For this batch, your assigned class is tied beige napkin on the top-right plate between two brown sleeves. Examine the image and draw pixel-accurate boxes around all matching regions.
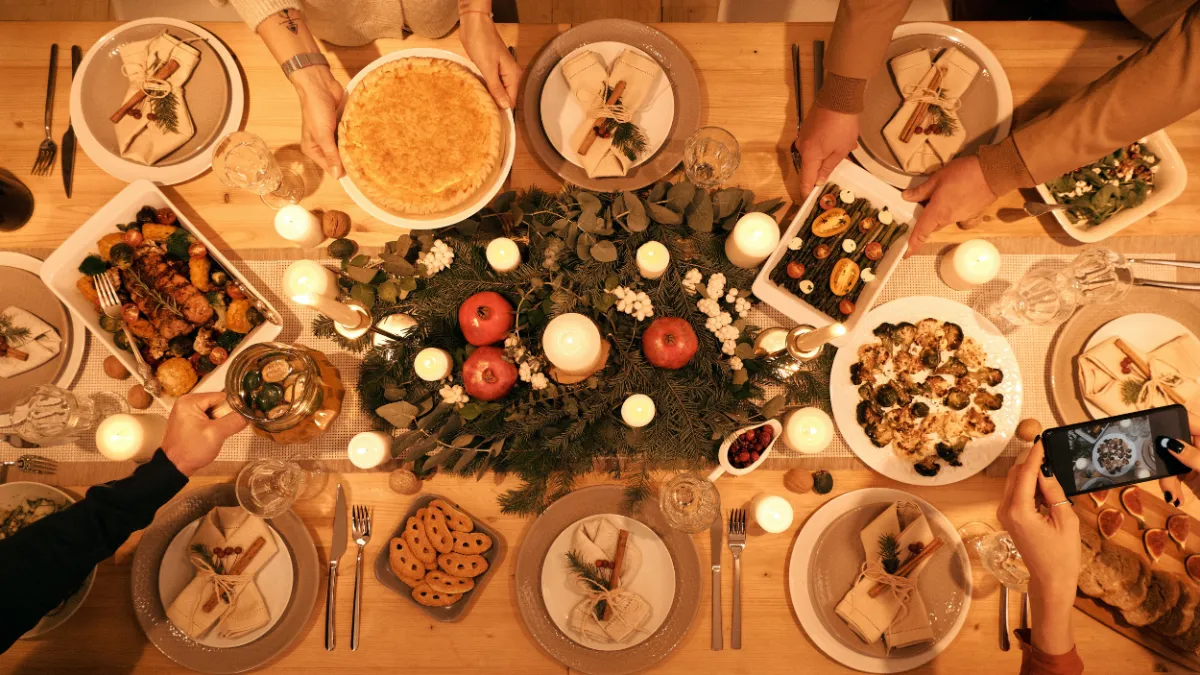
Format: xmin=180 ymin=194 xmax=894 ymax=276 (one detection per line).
xmin=883 ymin=47 xmax=979 ymax=174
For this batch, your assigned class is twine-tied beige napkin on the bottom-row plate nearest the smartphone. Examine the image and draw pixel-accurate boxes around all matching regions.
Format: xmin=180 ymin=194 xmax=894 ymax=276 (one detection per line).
xmin=834 ymin=502 xmax=934 ymax=651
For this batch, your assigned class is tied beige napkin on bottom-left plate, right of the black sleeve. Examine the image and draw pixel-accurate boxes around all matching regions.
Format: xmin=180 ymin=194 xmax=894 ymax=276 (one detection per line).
xmin=167 ymin=507 xmax=277 ymax=639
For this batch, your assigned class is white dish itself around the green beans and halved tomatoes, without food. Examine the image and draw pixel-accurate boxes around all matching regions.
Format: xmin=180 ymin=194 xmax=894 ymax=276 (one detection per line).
xmin=751 ymin=160 xmax=922 ymax=347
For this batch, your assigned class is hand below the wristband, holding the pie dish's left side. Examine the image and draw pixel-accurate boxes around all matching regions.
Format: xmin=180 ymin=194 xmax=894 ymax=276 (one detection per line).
xmin=292 ymin=66 xmax=346 ymax=178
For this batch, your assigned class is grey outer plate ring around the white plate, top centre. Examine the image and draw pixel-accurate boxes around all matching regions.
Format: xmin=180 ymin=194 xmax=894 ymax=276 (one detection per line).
xmin=521 ymin=19 xmax=701 ymax=190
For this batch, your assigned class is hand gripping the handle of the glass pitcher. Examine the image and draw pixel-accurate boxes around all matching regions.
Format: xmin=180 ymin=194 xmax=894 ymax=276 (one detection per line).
xmin=162 ymin=392 xmax=246 ymax=476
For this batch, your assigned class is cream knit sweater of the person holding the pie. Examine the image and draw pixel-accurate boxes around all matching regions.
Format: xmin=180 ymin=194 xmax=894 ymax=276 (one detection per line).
xmin=212 ymin=0 xmax=458 ymax=47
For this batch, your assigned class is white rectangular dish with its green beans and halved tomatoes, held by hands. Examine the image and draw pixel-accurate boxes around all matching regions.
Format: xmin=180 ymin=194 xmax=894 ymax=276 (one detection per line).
xmin=754 ymin=161 xmax=920 ymax=346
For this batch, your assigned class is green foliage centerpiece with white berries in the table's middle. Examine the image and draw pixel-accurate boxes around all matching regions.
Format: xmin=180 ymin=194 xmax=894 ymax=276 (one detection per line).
xmin=313 ymin=176 xmax=828 ymax=514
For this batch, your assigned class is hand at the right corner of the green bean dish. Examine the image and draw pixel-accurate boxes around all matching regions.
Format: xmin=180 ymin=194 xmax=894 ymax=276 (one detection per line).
xmin=904 ymin=155 xmax=996 ymax=258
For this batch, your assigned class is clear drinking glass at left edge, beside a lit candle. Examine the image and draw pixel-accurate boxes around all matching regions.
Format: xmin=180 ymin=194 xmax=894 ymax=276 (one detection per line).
xmin=0 ymin=384 xmax=130 ymax=446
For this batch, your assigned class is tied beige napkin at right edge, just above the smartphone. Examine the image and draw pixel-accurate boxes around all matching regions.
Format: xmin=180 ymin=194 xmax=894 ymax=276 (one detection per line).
xmin=1079 ymin=335 xmax=1200 ymax=416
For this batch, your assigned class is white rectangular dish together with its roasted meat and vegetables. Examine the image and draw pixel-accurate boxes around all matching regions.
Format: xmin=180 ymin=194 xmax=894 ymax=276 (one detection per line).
xmin=42 ymin=180 xmax=282 ymax=408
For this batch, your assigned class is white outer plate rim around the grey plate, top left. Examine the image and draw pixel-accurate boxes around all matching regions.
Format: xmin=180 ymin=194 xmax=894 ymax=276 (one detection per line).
xmin=71 ymin=17 xmax=246 ymax=185
